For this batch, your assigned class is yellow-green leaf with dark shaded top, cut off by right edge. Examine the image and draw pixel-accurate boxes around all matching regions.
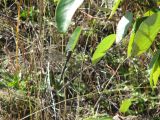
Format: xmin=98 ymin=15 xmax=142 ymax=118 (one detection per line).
xmin=149 ymin=50 xmax=160 ymax=88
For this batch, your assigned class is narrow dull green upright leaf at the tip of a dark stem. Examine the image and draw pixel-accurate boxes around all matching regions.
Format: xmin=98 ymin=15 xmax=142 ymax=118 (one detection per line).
xmin=66 ymin=26 xmax=82 ymax=52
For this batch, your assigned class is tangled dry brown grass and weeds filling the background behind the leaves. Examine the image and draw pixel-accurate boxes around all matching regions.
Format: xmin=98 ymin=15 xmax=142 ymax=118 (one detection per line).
xmin=0 ymin=0 xmax=160 ymax=120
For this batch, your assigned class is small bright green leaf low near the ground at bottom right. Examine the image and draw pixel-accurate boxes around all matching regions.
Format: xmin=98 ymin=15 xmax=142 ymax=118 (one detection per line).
xmin=119 ymin=99 xmax=133 ymax=113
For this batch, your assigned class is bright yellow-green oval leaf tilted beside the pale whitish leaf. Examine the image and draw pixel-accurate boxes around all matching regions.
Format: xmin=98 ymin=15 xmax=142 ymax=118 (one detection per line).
xmin=92 ymin=34 xmax=116 ymax=64
